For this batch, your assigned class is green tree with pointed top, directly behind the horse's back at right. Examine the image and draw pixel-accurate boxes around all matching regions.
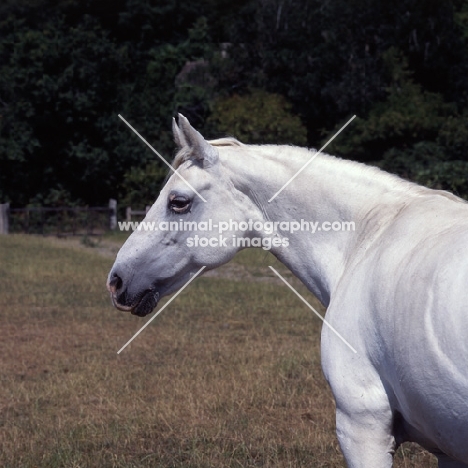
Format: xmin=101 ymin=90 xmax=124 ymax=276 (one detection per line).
xmin=334 ymin=48 xmax=468 ymax=198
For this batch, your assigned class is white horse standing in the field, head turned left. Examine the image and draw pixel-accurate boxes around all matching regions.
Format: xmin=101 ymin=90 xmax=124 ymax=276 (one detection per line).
xmin=108 ymin=116 xmax=468 ymax=468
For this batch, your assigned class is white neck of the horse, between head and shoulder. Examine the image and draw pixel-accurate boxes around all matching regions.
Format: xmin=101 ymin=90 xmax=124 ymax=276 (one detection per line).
xmin=220 ymin=146 xmax=416 ymax=306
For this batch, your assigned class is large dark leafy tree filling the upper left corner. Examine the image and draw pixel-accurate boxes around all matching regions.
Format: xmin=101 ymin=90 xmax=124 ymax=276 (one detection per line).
xmin=0 ymin=0 xmax=218 ymax=205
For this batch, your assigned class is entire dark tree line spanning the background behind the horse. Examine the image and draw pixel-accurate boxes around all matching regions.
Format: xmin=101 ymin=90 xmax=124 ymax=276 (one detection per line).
xmin=0 ymin=0 xmax=468 ymax=206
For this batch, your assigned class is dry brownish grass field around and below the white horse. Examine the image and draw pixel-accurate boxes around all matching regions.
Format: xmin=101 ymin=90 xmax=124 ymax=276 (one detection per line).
xmin=0 ymin=235 xmax=436 ymax=468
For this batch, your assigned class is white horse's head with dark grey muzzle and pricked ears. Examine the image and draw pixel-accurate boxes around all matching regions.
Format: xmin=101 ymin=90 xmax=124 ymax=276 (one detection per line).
xmin=107 ymin=115 xmax=261 ymax=317
